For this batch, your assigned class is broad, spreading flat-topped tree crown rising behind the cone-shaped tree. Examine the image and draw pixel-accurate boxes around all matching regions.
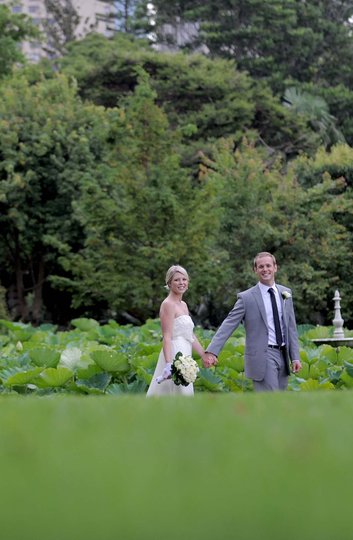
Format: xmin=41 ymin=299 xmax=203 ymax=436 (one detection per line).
xmin=61 ymin=34 xmax=320 ymax=161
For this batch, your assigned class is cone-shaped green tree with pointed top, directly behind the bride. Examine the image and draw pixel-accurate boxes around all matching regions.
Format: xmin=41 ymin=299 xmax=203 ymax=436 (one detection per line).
xmin=55 ymin=73 xmax=217 ymax=321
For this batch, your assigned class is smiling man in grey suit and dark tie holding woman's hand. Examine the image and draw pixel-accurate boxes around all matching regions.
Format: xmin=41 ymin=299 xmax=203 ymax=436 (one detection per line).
xmin=206 ymin=251 xmax=301 ymax=391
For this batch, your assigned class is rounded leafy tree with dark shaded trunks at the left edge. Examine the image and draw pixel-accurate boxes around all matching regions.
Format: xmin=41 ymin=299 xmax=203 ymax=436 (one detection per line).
xmin=0 ymin=75 xmax=106 ymax=322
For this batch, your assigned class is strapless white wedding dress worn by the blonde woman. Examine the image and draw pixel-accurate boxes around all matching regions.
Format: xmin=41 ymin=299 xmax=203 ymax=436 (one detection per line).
xmin=147 ymin=315 xmax=194 ymax=397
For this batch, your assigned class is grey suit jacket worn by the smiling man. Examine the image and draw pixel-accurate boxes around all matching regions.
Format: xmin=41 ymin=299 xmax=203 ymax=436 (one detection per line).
xmin=207 ymin=283 xmax=299 ymax=381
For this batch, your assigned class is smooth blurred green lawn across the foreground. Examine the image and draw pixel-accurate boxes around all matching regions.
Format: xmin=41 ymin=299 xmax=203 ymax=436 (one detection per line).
xmin=0 ymin=391 xmax=353 ymax=540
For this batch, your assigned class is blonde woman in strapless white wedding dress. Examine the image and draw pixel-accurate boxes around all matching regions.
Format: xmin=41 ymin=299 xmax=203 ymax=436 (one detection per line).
xmin=147 ymin=265 xmax=209 ymax=396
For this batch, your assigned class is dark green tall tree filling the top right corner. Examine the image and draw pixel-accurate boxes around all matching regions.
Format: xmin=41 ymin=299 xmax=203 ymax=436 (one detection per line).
xmin=154 ymin=0 xmax=353 ymax=91
